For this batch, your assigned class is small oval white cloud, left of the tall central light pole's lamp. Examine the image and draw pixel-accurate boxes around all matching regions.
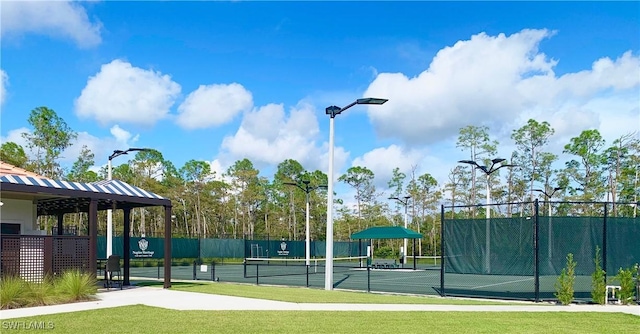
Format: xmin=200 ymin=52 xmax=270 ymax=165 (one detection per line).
xmin=176 ymin=83 xmax=253 ymax=129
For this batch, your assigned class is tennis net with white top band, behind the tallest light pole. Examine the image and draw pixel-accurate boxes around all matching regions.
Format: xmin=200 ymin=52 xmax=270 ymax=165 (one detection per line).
xmin=244 ymin=256 xmax=367 ymax=278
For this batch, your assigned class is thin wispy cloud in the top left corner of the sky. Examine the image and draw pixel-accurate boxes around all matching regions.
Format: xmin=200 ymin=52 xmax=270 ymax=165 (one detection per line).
xmin=0 ymin=1 xmax=102 ymax=48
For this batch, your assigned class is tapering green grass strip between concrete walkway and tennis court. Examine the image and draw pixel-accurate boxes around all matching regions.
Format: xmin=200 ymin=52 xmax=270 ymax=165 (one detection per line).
xmin=137 ymin=282 xmax=516 ymax=305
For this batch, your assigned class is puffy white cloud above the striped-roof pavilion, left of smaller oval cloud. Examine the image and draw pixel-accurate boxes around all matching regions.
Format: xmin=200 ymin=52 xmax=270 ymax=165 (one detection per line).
xmin=75 ymin=60 xmax=180 ymax=125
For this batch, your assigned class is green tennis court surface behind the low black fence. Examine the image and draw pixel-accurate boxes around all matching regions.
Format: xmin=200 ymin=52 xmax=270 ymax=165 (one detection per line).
xmin=126 ymin=258 xmax=591 ymax=300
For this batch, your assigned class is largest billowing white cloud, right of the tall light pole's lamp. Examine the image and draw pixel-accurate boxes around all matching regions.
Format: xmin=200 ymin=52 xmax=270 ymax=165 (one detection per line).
xmin=364 ymin=30 xmax=640 ymax=145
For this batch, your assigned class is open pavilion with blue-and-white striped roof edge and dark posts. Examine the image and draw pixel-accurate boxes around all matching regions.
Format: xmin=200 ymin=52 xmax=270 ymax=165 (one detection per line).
xmin=0 ymin=175 xmax=171 ymax=288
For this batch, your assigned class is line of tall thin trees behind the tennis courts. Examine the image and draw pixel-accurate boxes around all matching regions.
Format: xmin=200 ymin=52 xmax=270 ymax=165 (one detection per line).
xmin=0 ymin=107 xmax=640 ymax=254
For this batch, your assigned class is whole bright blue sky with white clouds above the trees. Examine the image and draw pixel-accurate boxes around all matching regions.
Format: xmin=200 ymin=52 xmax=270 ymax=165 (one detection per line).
xmin=0 ymin=1 xmax=640 ymax=196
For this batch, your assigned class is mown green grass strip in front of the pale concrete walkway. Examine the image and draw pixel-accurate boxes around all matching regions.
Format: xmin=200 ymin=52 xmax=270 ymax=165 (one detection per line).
xmin=6 ymin=305 xmax=640 ymax=334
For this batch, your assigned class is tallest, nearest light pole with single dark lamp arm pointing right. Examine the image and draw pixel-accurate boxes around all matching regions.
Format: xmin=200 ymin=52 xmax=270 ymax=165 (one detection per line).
xmin=324 ymin=98 xmax=388 ymax=290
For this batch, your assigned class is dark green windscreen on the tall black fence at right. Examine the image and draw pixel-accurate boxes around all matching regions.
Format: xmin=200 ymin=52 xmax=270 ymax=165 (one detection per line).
xmin=443 ymin=216 xmax=640 ymax=276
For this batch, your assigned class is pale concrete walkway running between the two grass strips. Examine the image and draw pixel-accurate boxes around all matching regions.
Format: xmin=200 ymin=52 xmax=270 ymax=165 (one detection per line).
xmin=0 ymin=287 xmax=640 ymax=320
